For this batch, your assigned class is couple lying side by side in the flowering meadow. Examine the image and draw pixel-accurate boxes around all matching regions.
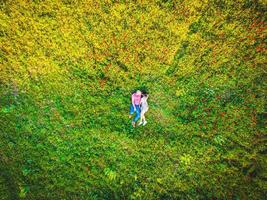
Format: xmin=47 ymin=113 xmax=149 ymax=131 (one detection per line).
xmin=129 ymin=90 xmax=148 ymax=127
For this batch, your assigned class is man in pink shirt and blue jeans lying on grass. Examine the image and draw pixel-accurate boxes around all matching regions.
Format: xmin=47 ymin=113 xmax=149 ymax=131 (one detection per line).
xmin=129 ymin=90 xmax=142 ymax=127
